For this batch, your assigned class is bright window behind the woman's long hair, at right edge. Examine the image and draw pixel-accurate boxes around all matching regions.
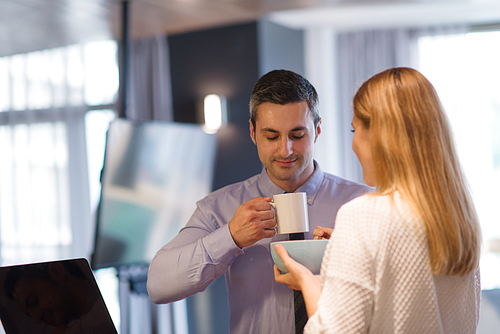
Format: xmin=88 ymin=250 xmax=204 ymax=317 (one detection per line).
xmin=419 ymin=32 xmax=500 ymax=289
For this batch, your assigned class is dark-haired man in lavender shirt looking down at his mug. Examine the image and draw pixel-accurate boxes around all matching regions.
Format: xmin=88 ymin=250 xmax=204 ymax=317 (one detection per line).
xmin=148 ymin=70 xmax=369 ymax=334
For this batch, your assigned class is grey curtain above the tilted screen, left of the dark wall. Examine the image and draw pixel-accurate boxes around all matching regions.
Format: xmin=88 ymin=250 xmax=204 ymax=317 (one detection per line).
xmin=127 ymin=36 xmax=173 ymax=122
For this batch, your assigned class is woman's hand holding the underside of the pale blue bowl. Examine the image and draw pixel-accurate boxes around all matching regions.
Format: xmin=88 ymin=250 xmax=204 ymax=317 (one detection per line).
xmin=274 ymin=244 xmax=315 ymax=290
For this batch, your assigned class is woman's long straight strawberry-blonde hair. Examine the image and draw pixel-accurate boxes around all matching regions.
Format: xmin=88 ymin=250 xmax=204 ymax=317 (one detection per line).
xmin=353 ymin=68 xmax=481 ymax=275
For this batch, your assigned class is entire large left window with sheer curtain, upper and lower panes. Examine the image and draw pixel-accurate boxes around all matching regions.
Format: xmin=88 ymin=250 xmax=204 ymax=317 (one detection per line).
xmin=0 ymin=41 xmax=118 ymax=265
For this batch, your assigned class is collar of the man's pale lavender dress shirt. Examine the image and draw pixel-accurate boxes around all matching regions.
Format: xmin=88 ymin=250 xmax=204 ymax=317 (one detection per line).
xmin=259 ymin=160 xmax=324 ymax=205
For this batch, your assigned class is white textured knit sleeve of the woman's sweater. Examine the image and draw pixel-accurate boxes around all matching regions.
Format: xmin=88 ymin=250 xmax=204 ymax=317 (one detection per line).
xmin=305 ymin=196 xmax=376 ymax=333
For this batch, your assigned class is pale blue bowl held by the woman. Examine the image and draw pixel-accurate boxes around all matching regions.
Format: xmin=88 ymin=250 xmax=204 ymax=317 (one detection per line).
xmin=271 ymin=240 xmax=328 ymax=275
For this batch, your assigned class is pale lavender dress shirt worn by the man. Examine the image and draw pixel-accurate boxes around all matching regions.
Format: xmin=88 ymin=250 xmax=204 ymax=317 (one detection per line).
xmin=148 ymin=162 xmax=370 ymax=334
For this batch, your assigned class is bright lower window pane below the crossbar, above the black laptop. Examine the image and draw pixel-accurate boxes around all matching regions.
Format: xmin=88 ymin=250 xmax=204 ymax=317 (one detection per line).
xmin=0 ymin=122 xmax=72 ymax=263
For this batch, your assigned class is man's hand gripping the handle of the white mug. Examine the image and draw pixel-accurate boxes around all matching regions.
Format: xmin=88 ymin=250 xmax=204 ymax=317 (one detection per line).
xmin=229 ymin=197 xmax=276 ymax=248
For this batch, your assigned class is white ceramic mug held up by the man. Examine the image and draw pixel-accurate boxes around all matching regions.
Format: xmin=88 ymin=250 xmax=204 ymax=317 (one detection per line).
xmin=271 ymin=192 xmax=309 ymax=234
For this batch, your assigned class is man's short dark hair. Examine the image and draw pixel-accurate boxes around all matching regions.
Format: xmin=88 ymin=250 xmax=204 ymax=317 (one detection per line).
xmin=250 ymin=70 xmax=320 ymax=128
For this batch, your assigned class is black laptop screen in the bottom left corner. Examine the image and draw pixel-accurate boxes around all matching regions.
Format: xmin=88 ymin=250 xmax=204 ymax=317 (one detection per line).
xmin=0 ymin=258 xmax=117 ymax=334
